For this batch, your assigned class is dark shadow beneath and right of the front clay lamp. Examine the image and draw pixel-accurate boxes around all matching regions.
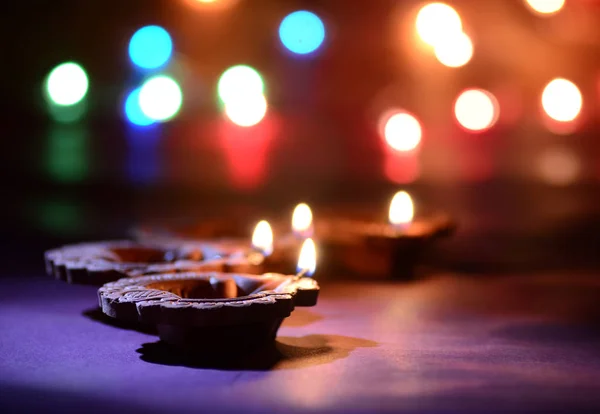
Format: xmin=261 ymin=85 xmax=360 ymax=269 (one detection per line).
xmin=137 ymin=335 xmax=378 ymax=371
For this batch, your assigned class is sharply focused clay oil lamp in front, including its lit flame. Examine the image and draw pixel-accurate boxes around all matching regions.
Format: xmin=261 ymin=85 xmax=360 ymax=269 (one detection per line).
xmin=98 ymin=239 xmax=319 ymax=352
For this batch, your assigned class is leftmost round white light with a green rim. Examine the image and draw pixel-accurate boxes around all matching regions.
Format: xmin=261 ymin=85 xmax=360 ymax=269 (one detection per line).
xmin=46 ymin=62 xmax=89 ymax=106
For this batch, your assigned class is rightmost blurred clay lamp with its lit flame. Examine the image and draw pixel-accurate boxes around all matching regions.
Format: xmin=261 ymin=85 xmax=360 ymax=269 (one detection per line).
xmin=315 ymin=191 xmax=455 ymax=279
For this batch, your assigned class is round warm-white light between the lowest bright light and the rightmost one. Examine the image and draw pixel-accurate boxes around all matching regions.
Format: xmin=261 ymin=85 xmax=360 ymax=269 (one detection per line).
xmin=454 ymin=89 xmax=500 ymax=132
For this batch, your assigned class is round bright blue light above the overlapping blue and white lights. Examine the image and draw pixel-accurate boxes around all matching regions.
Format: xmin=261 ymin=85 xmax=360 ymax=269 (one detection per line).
xmin=129 ymin=26 xmax=173 ymax=69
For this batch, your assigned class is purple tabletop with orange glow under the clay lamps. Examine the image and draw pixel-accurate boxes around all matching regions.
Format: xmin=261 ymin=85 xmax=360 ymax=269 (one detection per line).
xmin=0 ymin=275 xmax=600 ymax=413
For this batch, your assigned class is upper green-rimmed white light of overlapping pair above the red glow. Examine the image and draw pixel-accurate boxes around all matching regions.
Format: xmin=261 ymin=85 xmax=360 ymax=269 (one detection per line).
xmin=217 ymin=65 xmax=265 ymax=103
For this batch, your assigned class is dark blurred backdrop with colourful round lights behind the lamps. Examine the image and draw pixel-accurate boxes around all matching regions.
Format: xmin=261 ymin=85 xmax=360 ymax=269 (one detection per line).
xmin=0 ymin=0 xmax=600 ymax=273
